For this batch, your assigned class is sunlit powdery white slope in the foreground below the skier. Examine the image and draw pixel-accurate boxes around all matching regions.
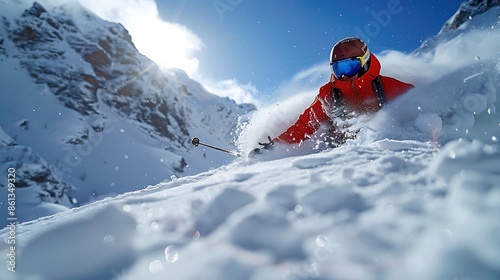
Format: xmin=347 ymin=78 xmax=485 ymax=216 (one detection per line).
xmin=0 ymin=0 xmax=500 ymax=280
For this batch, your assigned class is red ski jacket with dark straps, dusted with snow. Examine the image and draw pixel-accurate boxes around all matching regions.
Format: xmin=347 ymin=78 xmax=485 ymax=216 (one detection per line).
xmin=274 ymin=53 xmax=414 ymax=144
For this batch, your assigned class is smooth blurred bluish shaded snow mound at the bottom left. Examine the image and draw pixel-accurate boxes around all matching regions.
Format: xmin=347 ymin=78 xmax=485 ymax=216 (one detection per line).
xmin=18 ymin=205 xmax=137 ymax=279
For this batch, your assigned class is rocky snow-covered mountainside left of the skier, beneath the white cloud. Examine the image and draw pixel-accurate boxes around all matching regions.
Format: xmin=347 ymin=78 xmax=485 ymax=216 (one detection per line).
xmin=0 ymin=1 xmax=255 ymax=219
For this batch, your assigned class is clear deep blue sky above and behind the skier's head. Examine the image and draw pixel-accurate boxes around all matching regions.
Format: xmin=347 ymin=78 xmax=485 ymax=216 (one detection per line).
xmin=156 ymin=0 xmax=463 ymax=96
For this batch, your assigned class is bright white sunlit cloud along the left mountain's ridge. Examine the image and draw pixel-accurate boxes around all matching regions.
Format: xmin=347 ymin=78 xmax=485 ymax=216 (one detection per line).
xmin=78 ymin=0 xmax=259 ymax=105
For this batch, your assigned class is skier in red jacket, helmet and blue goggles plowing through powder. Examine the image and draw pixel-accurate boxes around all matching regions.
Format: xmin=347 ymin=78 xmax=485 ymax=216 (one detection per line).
xmin=251 ymin=37 xmax=414 ymax=154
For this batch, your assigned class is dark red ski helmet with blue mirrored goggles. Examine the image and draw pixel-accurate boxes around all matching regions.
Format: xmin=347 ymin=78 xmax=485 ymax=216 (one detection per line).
xmin=330 ymin=37 xmax=370 ymax=79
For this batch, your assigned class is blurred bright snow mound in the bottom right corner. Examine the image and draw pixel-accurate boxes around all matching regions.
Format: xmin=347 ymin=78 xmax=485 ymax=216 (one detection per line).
xmin=395 ymin=141 xmax=500 ymax=279
